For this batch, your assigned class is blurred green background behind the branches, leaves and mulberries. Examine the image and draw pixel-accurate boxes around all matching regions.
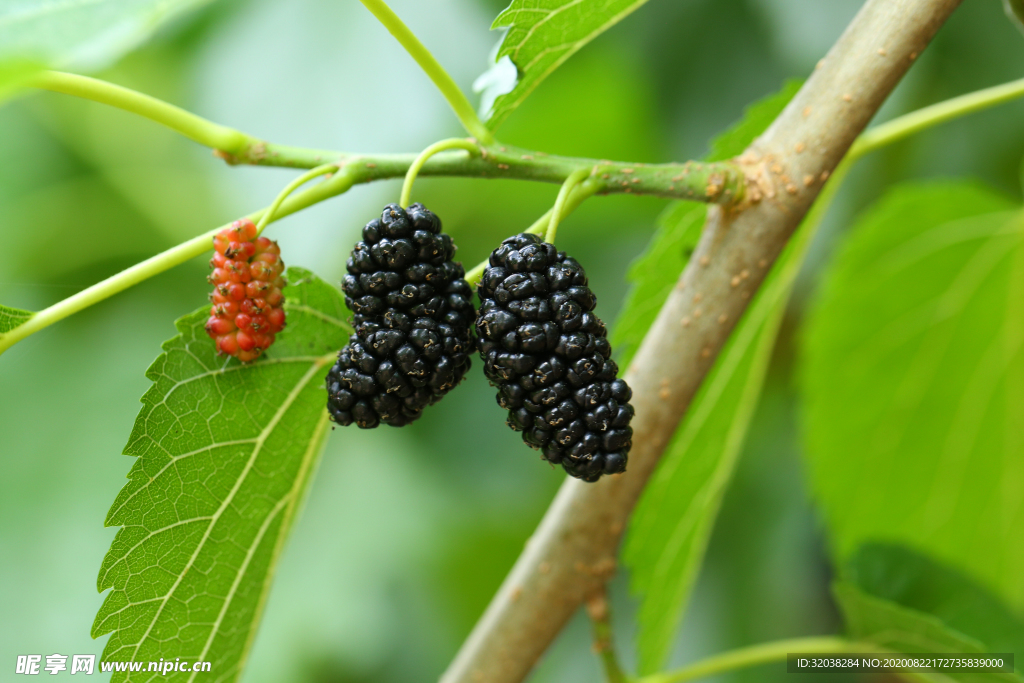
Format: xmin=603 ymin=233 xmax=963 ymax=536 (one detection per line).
xmin=6 ymin=0 xmax=1024 ymax=683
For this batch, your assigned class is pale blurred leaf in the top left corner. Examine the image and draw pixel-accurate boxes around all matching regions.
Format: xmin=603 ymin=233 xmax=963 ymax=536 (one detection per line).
xmin=0 ymin=0 xmax=216 ymax=98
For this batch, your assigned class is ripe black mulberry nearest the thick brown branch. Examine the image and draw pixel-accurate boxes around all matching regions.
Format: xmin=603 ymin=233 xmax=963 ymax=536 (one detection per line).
xmin=476 ymin=232 xmax=633 ymax=481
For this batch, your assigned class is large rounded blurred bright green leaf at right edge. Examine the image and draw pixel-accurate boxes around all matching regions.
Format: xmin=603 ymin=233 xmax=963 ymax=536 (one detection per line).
xmin=802 ymin=182 xmax=1024 ymax=609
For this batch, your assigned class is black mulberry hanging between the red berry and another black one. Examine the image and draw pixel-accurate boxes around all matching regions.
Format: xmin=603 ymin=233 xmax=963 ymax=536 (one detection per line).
xmin=327 ymin=204 xmax=475 ymax=429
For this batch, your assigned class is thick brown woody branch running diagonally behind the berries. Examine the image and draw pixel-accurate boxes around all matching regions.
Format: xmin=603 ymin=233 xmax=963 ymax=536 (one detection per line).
xmin=441 ymin=0 xmax=961 ymax=683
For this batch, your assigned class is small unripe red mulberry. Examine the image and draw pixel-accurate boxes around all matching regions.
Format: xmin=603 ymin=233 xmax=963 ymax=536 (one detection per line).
xmin=206 ymin=219 xmax=285 ymax=362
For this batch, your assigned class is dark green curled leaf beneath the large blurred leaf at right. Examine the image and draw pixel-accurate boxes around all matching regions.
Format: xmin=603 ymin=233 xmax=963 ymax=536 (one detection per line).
xmin=844 ymin=543 xmax=1024 ymax=652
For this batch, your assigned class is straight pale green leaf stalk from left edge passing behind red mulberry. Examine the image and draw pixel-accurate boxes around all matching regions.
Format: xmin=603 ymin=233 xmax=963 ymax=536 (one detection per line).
xmin=0 ymin=167 xmax=352 ymax=353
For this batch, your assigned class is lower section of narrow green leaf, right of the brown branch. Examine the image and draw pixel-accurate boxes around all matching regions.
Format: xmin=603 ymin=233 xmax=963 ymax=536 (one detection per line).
xmin=624 ymin=218 xmax=811 ymax=675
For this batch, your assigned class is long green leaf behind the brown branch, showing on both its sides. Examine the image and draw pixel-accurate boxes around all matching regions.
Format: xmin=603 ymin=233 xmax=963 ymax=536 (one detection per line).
xmin=614 ymin=83 xmax=802 ymax=674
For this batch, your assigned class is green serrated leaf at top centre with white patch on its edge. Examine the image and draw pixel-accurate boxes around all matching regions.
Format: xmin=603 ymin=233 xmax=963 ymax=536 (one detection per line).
xmin=476 ymin=0 xmax=647 ymax=130
